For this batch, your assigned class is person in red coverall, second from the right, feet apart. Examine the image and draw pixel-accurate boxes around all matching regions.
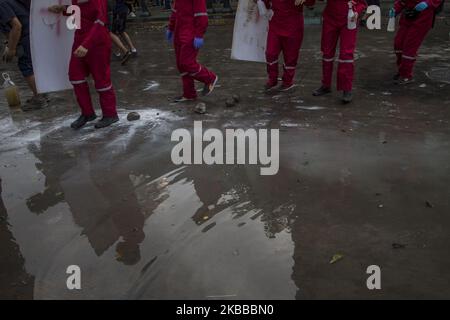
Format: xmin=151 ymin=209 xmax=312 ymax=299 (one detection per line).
xmin=313 ymin=0 xmax=367 ymax=103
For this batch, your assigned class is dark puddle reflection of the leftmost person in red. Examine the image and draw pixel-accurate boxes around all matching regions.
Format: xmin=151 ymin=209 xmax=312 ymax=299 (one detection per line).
xmin=27 ymin=131 xmax=146 ymax=265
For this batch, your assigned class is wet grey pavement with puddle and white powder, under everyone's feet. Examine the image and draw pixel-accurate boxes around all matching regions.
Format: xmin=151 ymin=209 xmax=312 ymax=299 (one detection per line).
xmin=0 ymin=20 xmax=450 ymax=299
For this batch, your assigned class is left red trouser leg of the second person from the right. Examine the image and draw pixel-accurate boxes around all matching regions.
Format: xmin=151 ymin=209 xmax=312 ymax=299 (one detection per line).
xmin=321 ymin=15 xmax=339 ymax=88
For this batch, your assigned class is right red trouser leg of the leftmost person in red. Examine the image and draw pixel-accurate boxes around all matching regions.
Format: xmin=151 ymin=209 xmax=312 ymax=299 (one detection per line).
xmin=86 ymin=41 xmax=117 ymax=117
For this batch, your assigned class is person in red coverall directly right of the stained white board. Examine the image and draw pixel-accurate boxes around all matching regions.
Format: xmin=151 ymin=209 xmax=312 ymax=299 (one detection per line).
xmin=260 ymin=0 xmax=315 ymax=92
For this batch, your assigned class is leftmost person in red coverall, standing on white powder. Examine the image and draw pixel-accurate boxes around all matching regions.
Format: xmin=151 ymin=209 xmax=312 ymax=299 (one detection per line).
xmin=48 ymin=0 xmax=119 ymax=129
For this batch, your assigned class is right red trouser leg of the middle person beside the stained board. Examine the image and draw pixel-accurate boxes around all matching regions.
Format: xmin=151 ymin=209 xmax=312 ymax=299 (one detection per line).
xmin=281 ymin=28 xmax=303 ymax=87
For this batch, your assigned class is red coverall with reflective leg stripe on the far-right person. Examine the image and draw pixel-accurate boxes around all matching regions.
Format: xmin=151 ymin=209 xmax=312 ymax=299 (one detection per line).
xmin=394 ymin=0 xmax=442 ymax=78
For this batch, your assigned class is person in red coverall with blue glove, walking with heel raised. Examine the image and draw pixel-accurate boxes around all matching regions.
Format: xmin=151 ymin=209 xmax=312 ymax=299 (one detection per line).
xmin=166 ymin=0 xmax=219 ymax=102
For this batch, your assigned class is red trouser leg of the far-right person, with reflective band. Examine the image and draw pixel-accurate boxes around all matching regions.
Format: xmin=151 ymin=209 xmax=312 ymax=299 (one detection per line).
xmin=399 ymin=9 xmax=434 ymax=78
